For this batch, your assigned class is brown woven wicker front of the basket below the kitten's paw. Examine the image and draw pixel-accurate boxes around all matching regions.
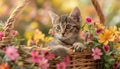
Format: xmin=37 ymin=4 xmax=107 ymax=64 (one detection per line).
xmin=50 ymin=49 xmax=100 ymax=69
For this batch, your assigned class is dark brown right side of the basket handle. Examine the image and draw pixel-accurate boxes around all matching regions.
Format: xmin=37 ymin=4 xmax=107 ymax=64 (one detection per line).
xmin=91 ymin=0 xmax=106 ymax=25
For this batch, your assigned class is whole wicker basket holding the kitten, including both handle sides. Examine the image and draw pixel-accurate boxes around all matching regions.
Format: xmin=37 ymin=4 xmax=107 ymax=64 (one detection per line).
xmin=0 ymin=0 xmax=105 ymax=69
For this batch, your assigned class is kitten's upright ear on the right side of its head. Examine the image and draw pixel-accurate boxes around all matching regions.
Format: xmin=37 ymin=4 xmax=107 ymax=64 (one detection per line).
xmin=69 ymin=7 xmax=81 ymax=22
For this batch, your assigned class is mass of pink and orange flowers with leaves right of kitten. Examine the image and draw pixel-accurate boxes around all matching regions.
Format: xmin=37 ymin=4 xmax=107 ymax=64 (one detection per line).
xmin=80 ymin=17 xmax=120 ymax=69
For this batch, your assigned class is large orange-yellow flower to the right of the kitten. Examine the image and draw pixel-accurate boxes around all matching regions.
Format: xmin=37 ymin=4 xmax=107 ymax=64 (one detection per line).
xmin=98 ymin=29 xmax=115 ymax=45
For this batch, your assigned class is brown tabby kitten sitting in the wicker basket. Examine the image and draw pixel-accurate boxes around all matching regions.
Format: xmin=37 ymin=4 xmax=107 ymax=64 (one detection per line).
xmin=47 ymin=7 xmax=85 ymax=57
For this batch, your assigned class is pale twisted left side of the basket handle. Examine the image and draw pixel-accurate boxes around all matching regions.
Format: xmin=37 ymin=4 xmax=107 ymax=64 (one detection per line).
xmin=4 ymin=0 xmax=29 ymax=37
